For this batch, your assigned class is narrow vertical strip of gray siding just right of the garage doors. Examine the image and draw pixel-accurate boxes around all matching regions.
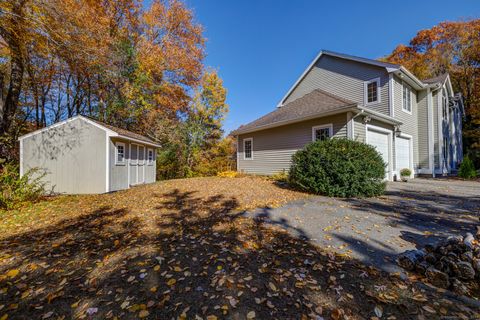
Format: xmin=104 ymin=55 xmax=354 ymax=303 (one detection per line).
xmin=417 ymin=90 xmax=430 ymax=169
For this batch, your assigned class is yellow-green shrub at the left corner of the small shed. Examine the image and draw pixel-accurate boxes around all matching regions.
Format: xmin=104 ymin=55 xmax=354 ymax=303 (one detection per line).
xmin=0 ymin=164 xmax=45 ymax=210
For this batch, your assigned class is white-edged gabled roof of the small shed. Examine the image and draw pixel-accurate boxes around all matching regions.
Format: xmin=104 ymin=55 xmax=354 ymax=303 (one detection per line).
xmin=18 ymin=115 xmax=160 ymax=147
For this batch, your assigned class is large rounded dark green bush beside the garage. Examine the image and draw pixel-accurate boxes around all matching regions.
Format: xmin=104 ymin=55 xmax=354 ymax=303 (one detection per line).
xmin=290 ymin=139 xmax=386 ymax=197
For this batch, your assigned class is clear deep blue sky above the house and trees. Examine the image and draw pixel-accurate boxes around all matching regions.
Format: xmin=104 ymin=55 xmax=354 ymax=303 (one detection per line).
xmin=182 ymin=0 xmax=480 ymax=133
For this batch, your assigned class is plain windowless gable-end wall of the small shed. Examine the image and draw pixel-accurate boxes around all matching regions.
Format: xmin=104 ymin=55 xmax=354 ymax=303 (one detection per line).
xmin=22 ymin=119 xmax=107 ymax=194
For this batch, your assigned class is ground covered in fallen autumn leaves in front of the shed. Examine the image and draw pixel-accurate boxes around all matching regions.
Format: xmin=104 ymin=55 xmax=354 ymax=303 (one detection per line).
xmin=0 ymin=177 xmax=478 ymax=320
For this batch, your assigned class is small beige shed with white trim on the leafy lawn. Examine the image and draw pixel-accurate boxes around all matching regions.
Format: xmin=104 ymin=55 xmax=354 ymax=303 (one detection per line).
xmin=19 ymin=115 xmax=159 ymax=194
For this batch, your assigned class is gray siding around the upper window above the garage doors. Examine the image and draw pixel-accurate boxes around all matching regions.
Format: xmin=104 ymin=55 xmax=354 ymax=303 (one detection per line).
xmin=393 ymin=76 xmax=418 ymax=171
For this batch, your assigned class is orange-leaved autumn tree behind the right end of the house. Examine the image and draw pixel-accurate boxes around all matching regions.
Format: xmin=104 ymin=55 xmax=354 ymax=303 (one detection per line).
xmin=385 ymin=19 xmax=480 ymax=163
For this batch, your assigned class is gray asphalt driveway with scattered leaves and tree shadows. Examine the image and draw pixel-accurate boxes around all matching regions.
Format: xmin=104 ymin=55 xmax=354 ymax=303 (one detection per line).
xmin=247 ymin=179 xmax=480 ymax=272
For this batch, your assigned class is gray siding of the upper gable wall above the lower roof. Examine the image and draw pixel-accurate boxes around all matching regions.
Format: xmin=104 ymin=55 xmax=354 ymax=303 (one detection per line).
xmin=285 ymin=55 xmax=389 ymax=114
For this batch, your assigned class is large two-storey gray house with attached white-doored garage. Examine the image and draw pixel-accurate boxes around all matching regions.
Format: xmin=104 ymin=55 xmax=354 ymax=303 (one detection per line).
xmin=232 ymin=51 xmax=464 ymax=180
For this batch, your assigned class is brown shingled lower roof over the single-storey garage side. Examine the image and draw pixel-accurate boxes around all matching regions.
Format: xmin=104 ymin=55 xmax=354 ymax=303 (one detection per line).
xmin=232 ymin=89 xmax=357 ymax=135
